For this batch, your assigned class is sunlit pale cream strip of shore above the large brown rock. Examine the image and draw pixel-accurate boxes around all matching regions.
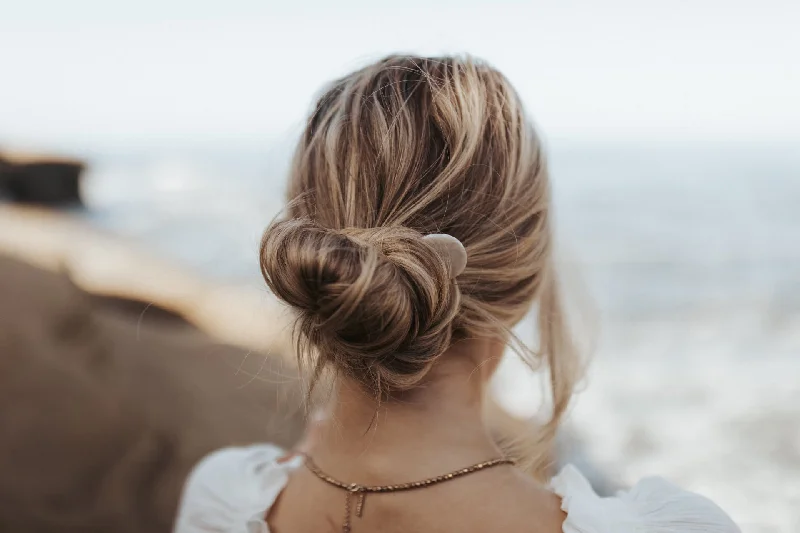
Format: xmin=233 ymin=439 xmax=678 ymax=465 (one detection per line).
xmin=0 ymin=204 xmax=295 ymax=362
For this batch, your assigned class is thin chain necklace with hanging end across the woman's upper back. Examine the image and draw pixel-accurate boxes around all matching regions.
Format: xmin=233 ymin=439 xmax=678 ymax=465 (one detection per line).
xmin=304 ymin=455 xmax=514 ymax=533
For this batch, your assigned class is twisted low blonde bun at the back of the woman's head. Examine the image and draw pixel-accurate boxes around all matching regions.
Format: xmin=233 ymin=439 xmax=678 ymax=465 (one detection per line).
xmin=261 ymin=219 xmax=461 ymax=393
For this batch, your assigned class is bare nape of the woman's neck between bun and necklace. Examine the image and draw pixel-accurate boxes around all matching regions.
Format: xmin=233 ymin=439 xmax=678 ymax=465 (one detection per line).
xmin=307 ymin=341 xmax=501 ymax=483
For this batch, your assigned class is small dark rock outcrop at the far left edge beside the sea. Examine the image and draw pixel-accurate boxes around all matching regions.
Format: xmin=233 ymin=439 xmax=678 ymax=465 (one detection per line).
xmin=0 ymin=154 xmax=85 ymax=206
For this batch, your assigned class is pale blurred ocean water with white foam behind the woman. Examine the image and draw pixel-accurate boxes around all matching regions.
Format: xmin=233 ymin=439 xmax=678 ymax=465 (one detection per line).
xmin=79 ymin=143 xmax=800 ymax=533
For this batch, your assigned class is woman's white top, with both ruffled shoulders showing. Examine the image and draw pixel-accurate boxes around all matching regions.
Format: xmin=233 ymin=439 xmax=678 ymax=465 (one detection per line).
xmin=174 ymin=444 xmax=741 ymax=533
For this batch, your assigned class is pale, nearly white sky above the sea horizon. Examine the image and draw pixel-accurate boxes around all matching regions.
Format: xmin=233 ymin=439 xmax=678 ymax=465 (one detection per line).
xmin=0 ymin=0 xmax=800 ymax=151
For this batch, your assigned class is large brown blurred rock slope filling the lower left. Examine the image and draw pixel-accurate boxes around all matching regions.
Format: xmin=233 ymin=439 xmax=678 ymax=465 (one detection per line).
xmin=0 ymin=256 xmax=304 ymax=533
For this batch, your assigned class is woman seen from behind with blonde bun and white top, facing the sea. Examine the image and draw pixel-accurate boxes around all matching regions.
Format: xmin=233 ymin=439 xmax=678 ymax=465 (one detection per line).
xmin=176 ymin=57 xmax=738 ymax=533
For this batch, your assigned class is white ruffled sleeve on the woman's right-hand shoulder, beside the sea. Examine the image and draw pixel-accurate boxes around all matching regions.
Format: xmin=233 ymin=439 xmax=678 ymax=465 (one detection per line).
xmin=550 ymin=465 xmax=741 ymax=533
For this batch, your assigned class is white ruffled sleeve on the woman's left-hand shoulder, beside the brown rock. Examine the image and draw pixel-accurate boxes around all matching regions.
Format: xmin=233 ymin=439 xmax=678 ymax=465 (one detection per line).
xmin=173 ymin=444 xmax=300 ymax=533
